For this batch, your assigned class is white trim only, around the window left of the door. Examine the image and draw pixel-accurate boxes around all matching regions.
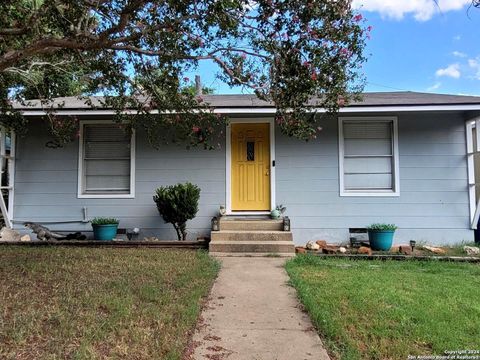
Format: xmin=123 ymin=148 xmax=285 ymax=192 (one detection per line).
xmin=77 ymin=120 xmax=136 ymax=199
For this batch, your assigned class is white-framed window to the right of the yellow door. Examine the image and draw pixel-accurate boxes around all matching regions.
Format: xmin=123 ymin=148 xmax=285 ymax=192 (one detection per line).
xmin=338 ymin=117 xmax=400 ymax=196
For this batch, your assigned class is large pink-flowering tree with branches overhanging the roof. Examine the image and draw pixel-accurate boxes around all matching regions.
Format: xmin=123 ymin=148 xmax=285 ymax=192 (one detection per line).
xmin=0 ymin=0 xmax=370 ymax=147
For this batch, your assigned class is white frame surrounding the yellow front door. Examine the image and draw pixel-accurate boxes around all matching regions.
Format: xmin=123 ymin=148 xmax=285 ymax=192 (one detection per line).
xmin=225 ymin=118 xmax=275 ymax=215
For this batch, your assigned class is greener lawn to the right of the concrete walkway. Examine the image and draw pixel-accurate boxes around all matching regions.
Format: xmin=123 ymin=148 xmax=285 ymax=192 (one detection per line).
xmin=286 ymin=255 xmax=480 ymax=360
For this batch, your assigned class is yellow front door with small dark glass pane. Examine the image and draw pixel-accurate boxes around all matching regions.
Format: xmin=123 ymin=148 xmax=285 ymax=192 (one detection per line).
xmin=231 ymin=123 xmax=270 ymax=211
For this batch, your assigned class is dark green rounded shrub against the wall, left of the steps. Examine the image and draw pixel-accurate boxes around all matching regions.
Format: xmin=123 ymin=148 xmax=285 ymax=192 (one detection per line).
xmin=153 ymin=182 xmax=200 ymax=240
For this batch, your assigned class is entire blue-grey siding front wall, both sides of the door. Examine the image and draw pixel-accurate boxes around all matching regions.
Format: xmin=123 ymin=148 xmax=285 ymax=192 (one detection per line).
xmin=14 ymin=114 xmax=473 ymax=244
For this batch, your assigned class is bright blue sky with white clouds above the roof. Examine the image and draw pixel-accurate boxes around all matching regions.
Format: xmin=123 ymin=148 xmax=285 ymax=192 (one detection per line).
xmin=189 ymin=0 xmax=480 ymax=96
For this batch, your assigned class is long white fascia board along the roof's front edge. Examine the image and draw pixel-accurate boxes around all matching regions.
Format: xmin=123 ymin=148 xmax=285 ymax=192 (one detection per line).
xmin=18 ymin=104 xmax=480 ymax=116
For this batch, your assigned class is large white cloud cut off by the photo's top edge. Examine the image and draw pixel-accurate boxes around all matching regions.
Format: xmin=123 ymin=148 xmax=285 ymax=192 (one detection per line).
xmin=353 ymin=0 xmax=471 ymax=21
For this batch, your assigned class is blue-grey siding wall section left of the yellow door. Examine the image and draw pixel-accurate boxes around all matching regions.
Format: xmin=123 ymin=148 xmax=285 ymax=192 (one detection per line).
xmin=14 ymin=120 xmax=225 ymax=239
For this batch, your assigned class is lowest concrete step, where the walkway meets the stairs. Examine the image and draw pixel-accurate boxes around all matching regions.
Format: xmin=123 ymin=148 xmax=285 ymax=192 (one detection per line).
xmin=209 ymin=241 xmax=295 ymax=254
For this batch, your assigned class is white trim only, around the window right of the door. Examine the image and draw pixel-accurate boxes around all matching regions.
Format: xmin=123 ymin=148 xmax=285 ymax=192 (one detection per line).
xmin=338 ymin=116 xmax=400 ymax=197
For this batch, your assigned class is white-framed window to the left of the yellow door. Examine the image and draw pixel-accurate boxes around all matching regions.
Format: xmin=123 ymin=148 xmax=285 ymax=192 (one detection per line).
xmin=78 ymin=121 xmax=135 ymax=198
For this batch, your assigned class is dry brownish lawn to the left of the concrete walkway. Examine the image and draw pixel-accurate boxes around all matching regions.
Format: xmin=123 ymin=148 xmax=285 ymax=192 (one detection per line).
xmin=0 ymin=247 xmax=219 ymax=360
